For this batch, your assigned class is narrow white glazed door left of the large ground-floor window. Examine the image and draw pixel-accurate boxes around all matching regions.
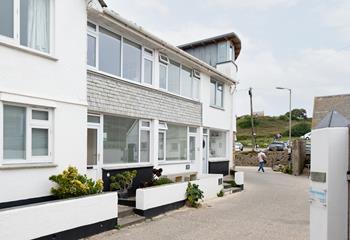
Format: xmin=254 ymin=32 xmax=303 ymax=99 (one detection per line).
xmin=87 ymin=126 xmax=101 ymax=180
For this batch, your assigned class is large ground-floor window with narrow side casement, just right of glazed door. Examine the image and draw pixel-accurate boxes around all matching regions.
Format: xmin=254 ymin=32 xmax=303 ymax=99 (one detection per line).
xmin=103 ymin=115 xmax=150 ymax=164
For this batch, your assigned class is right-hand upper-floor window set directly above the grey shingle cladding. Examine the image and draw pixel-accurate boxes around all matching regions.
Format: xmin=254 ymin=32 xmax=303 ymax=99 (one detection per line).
xmin=159 ymin=55 xmax=200 ymax=99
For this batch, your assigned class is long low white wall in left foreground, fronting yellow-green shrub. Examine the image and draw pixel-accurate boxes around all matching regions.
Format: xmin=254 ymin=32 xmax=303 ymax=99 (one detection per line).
xmin=0 ymin=193 xmax=118 ymax=240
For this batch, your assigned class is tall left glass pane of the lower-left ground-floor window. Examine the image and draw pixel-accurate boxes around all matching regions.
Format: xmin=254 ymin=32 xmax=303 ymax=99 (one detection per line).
xmin=4 ymin=106 xmax=26 ymax=159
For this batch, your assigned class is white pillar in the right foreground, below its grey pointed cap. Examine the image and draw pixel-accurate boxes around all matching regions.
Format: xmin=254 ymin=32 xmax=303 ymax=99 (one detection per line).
xmin=310 ymin=128 xmax=349 ymax=240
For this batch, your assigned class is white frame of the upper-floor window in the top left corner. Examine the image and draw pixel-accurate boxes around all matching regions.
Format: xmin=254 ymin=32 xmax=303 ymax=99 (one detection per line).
xmin=0 ymin=0 xmax=55 ymax=56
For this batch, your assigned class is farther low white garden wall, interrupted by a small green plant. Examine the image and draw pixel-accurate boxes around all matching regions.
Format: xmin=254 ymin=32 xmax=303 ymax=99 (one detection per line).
xmin=136 ymin=174 xmax=223 ymax=210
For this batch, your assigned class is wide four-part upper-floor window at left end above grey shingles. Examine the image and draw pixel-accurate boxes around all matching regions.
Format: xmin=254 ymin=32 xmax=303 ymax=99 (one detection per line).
xmin=87 ymin=22 xmax=154 ymax=84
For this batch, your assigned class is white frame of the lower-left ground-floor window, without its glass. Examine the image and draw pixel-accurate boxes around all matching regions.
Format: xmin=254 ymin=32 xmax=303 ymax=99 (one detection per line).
xmin=0 ymin=102 xmax=53 ymax=165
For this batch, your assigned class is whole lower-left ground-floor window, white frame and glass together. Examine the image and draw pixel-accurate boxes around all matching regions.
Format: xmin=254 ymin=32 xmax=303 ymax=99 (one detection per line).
xmin=3 ymin=104 xmax=52 ymax=163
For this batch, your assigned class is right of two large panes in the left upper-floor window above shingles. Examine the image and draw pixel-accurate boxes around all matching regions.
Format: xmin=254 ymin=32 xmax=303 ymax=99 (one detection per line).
xmin=123 ymin=39 xmax=141 ymax=82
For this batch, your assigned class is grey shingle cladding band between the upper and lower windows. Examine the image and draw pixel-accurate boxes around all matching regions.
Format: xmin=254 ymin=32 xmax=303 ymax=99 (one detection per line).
xmin=87 ymin=72 xmax=202 ymax=126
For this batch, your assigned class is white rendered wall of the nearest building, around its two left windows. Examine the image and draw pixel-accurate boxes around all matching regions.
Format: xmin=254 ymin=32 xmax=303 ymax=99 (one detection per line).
xmin=0 ymin=0 xmax=87 ymax=203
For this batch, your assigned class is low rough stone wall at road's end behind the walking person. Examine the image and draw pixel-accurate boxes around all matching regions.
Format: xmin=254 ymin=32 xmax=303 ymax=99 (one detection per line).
xmin=235 ymin=151 xmax=289 ymax=167
